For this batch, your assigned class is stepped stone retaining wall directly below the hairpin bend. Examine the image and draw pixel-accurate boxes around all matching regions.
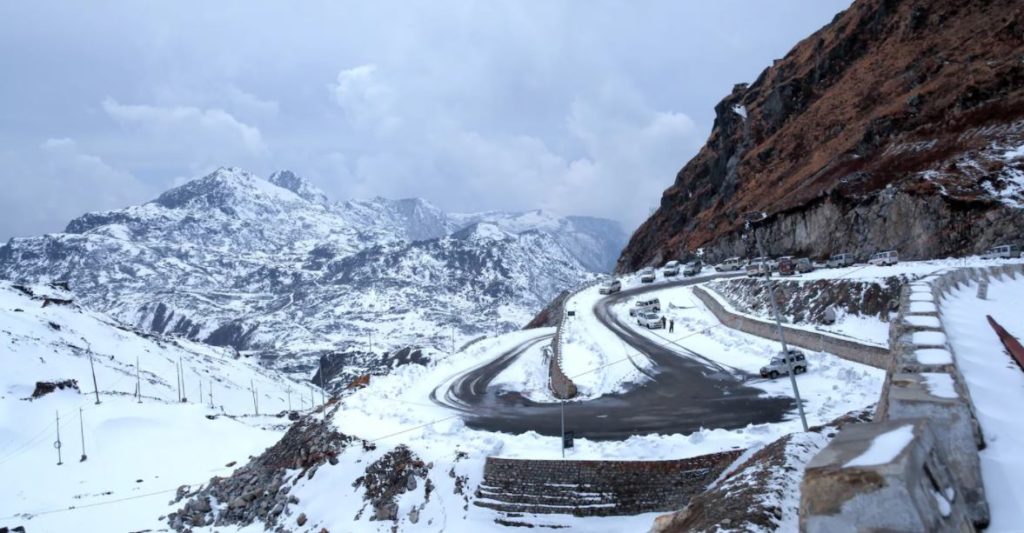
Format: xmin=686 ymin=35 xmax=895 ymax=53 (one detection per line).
xmin=474 ymin=450 xmax=743 ymax=517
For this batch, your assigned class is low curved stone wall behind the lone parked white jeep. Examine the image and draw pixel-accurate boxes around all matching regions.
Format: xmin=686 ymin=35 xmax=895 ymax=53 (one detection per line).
xmin=693 ymin=286 xmax=892 ymax=368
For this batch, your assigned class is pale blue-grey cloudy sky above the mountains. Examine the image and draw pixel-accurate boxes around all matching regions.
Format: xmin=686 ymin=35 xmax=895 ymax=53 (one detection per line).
xmin=0 ymin=0 xmax=849 ymax=239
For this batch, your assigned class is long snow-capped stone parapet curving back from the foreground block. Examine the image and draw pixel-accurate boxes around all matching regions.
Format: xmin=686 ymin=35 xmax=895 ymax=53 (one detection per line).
xmin=800 ymin=260 xmax=1024 ymax=531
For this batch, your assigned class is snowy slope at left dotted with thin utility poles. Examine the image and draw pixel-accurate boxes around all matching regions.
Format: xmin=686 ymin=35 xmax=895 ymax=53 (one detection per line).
xmin=0 ymin=282 xmax=303 ymax=532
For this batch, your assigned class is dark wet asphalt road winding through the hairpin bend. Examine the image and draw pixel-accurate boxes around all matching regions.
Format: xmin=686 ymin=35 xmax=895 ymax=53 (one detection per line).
xmin=431 ymin=272 xmax=796 ymax=440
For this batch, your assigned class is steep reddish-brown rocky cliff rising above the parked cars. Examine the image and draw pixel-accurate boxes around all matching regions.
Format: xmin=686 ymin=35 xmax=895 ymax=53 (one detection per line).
xmin=617 ymin=0 xmax=1024 ymax=270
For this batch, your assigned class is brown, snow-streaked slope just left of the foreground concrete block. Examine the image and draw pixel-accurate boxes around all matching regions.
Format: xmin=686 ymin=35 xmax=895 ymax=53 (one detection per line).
xmin=651 ymin=410 xmax=871 ymax=533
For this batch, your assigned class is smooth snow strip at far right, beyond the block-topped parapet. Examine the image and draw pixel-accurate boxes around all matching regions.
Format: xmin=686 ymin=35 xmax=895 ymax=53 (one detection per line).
xmin=942 ymin=278 xmax=1024 ymax=531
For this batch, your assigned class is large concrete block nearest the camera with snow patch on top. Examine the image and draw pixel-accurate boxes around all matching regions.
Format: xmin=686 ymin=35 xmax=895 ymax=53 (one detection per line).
xmin=800 ymin=419 xmax=973 ymax=533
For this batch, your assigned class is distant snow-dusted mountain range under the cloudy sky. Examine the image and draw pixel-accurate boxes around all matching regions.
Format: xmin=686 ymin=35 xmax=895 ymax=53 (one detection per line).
xmin=0 ymin=168 xmax=626 ymax=382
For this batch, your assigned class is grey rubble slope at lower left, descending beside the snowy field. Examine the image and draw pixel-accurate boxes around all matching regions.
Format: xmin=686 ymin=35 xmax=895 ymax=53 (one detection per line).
xmin=167 ymin=413 xmax=355 ymax=532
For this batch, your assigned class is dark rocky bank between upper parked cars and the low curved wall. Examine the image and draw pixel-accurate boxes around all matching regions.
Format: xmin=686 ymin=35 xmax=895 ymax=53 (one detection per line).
xmin=710 ymin=276 xmax=907 ymax=324
